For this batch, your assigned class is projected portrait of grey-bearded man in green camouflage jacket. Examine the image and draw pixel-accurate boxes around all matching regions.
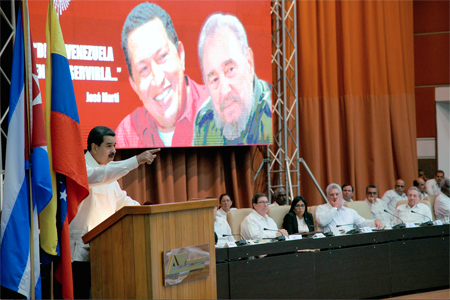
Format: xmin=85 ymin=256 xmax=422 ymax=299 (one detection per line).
xmin=193 ymin=14 xmax=272 ymax=145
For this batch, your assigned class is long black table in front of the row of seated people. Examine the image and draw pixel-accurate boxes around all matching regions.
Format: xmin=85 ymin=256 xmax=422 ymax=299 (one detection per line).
xmin=216 ymin=225 xmax=450 ymax=299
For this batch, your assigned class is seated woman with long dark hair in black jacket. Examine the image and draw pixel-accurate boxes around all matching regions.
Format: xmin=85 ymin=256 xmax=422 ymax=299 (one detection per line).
xmin=283 ymin=196 xmax=314 ymax=234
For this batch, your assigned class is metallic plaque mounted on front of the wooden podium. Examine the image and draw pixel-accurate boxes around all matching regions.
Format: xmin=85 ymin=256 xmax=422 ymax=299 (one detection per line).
xmin=163 ymin=244 xmax=209 ymax=286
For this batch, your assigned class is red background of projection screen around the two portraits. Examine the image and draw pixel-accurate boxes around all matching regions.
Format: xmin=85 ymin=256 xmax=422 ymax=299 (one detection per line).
xmin=29 ymin=0 xmax=272 ymax=148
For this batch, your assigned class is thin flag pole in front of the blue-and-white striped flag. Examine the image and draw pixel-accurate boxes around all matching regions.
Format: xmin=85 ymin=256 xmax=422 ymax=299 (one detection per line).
xmin=22 ymin=0 xmax=36 ymax=299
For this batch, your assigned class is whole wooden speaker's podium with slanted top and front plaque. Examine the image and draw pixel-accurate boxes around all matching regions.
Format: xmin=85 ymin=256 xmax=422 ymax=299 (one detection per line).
xmin=83 ymin=199 xmax=217 ymax=299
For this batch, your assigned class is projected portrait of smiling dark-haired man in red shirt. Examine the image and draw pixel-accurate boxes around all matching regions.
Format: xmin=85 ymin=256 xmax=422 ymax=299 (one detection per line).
xmin=116 ymin=2 xmax=208 ymax=148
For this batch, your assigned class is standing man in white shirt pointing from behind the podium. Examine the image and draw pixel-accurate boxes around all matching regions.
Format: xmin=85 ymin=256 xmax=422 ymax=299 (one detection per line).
xmin=69 ymin=126 xmax=160 ymax=299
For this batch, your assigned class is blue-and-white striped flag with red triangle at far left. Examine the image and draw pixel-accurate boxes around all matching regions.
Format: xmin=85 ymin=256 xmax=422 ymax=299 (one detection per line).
xmin=0 ymin=1 xmax=52 ymax=299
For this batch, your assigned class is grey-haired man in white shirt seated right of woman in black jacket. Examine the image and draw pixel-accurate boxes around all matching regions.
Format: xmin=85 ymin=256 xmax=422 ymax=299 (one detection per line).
xmin=316 ymin=183 xmax=383 ymax=234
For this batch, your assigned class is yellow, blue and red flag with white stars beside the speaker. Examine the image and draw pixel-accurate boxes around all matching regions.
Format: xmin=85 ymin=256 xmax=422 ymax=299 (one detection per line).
xmin=40 ymin=0 xmax=89 ymax=299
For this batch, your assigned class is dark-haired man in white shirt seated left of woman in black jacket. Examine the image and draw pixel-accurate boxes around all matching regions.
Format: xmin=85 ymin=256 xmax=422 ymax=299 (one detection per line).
xmin=241 ymin=193 xmax=288 ymax=240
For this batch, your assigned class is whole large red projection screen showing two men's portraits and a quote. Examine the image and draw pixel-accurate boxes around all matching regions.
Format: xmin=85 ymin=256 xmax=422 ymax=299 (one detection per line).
xmin=29 ymin=0 xmax=273 ymax=148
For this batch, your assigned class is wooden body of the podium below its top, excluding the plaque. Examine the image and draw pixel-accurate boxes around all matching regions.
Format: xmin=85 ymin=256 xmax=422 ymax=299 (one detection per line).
xmin=90 ymin=203 xmax=217 ymax=299
